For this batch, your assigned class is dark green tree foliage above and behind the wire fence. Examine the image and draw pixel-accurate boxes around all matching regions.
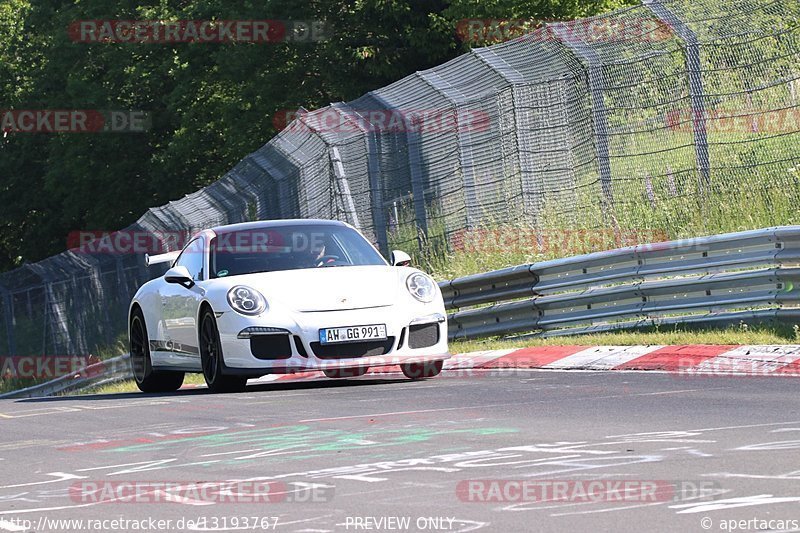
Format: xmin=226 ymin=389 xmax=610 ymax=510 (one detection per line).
xmin=0 ymin=0 xmax=628 ymax=270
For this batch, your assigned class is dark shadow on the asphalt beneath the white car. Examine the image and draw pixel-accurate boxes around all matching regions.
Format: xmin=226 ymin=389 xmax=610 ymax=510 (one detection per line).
xmin=14 ymin=378 xmax=416 ymax=403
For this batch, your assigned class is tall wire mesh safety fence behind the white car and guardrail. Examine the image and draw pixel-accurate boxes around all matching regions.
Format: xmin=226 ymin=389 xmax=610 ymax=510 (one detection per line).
xmin=0 ymin=0 xmax=800 ymax=355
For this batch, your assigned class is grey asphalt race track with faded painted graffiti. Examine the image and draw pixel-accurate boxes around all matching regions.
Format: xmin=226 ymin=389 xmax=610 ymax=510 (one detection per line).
xmin=0 ymin=370 xmax=800 ymax=533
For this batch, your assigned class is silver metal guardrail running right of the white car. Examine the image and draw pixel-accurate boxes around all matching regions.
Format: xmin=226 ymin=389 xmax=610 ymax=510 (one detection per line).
xmin=439 ymin=226 xmax=800 ymax=339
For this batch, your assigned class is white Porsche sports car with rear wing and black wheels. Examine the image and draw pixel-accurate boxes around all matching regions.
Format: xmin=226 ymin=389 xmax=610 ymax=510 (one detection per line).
xmin=128 ymin=220 xmax=450 ymax=392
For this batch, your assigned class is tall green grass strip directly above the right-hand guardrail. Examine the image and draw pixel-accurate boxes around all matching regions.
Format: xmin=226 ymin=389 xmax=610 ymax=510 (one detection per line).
xmin=389 ymin=161 xmax=800 ymax=280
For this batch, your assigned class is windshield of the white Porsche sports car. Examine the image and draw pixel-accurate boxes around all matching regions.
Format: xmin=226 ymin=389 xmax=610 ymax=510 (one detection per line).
xmin=209 ymin=224 xmax=386 ymax=278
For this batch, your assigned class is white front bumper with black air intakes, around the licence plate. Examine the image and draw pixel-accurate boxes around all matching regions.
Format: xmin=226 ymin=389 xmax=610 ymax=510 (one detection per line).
xmin=217 ymin=305 xmax=450 ymax=377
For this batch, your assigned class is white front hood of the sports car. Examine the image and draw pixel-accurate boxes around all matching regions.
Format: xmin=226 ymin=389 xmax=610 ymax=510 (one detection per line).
xmin=227 ymin=265 xmax=401 ymax=312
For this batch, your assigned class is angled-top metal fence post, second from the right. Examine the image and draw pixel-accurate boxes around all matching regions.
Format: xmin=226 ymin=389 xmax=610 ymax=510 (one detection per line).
xmin=547 ymin=23 xmax=614 ymax=208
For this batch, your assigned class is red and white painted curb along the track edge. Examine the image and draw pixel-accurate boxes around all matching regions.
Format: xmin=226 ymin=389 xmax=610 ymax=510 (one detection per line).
xmin=178 ymin=344 xmax=800 ymax=387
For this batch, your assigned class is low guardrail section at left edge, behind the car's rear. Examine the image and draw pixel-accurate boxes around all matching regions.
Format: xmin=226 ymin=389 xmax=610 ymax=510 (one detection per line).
xmin=0 ymin=354 xmax=131 ymax=399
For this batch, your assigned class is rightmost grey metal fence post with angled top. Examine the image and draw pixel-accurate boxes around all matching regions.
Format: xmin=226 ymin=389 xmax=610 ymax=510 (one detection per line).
xmin=642 ymin=0 xmax=711 ymax=186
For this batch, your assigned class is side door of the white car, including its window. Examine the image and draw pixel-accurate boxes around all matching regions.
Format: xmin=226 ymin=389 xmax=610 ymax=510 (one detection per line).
xmin=161 ymin=236 xmax=206 ymax=369
